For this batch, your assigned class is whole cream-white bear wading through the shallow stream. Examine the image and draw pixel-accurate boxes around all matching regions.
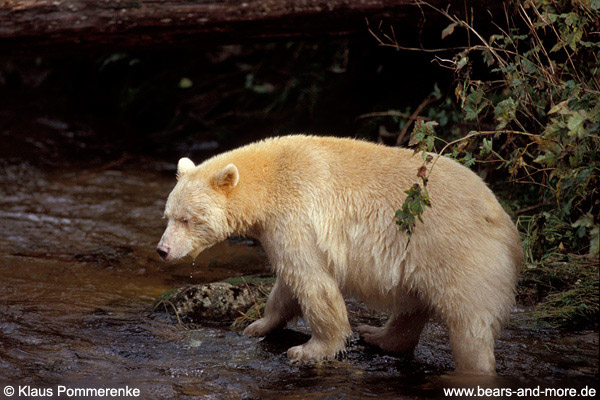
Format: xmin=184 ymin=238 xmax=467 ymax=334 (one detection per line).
xmin=157 ymin=135 xmax=522 ymax=374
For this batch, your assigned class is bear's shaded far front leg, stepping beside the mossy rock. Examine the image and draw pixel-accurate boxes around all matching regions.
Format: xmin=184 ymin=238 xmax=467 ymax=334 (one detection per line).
xmin=244 ymin=278 xmax=301 ymax=337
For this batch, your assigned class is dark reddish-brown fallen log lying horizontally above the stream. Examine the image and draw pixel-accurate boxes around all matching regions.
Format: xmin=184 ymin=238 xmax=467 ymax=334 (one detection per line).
xmin=0 ymin=0 xmax=502 ymax=49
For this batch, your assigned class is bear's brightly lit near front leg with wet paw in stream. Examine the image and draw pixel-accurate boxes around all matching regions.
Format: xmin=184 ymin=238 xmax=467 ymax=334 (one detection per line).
xmin=288 ymin=271 xmax=352 ymax=361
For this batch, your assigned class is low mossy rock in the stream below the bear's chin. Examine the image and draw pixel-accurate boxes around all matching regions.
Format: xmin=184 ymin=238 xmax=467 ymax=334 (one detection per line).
xmin=154 ymin=277 xmax=270 ymax=327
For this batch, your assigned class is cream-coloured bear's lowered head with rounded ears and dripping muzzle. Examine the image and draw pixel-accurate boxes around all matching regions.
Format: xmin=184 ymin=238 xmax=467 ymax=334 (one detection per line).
xmin=156 ymin=158 xmax=239 ymax=261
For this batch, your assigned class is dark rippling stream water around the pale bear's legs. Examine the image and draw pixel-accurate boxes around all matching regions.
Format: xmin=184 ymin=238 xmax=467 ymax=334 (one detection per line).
xmin=0 ymin=159 xmax=598 ymax=399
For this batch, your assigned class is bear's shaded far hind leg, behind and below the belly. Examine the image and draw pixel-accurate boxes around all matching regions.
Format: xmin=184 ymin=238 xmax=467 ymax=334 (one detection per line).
xmin=356 ymin=310 xmax=429 ymax=354
